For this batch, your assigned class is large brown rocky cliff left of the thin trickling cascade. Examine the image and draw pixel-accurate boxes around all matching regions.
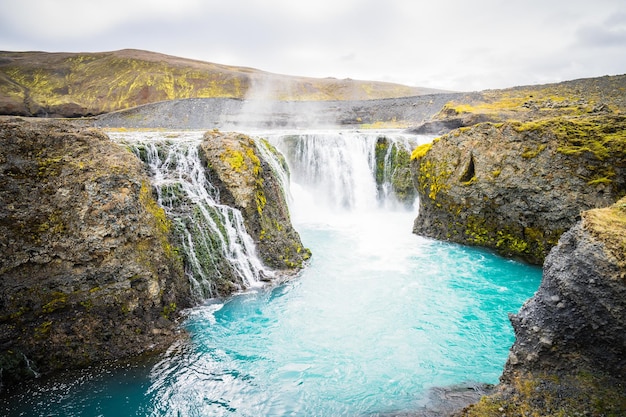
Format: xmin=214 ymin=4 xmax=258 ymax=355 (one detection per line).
xmin=0 ymin=119 xmax=189 ymax=383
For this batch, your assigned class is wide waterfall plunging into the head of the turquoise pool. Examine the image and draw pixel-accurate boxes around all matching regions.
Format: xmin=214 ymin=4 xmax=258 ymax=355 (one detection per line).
xmin=264 ymin=131 xmax=432 ymax=216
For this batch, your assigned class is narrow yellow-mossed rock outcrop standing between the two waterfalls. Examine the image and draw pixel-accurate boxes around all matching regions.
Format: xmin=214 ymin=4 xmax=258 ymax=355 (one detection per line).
xmin=200 ymin=131 xmax=311 ymax=273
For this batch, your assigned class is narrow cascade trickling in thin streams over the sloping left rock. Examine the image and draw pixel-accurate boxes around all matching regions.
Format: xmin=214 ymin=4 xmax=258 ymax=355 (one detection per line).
xmin=110 ymin=132 xmax=272 ymax=301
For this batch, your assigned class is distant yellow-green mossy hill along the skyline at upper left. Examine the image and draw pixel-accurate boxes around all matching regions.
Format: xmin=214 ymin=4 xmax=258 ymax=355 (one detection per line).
xmin=0 ymin=49 xmax=441 ymax=117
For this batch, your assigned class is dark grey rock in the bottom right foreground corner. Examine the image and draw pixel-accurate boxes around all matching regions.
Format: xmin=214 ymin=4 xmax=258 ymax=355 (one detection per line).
xmin=464 ymin=198 xmax=626 ymax=417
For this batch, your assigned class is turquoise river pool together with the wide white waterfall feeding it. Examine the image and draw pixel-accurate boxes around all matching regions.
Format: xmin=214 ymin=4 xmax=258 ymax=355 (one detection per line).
xmin=0 ymin=128 xmax=541 ymax=417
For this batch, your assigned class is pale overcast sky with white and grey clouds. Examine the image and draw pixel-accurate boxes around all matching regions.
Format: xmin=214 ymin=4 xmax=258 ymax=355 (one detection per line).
xmin=0 ymin=0 xmax=626 ymax=91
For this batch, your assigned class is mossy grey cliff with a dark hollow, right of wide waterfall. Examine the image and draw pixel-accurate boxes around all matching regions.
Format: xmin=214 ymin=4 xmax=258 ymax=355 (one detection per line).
xmin=412 ymin=115 xmax=626 ymax=264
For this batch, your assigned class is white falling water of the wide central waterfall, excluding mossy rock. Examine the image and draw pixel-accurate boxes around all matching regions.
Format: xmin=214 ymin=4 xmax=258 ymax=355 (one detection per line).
xmin=263 ymin=130 xmax=432 ymax=223
